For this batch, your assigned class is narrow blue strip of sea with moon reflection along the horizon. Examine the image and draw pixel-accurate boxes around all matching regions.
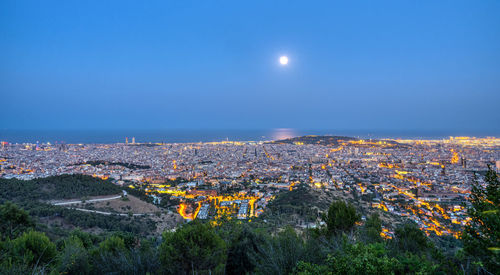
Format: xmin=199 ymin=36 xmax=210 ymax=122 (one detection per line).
xmin=0 ymin=128 xmax=500 ymax=144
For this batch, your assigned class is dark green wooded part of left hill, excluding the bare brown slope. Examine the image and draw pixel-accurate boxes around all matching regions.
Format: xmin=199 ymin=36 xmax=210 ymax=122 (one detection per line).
xmin=0 ymin=175 xmax=156 ymax=235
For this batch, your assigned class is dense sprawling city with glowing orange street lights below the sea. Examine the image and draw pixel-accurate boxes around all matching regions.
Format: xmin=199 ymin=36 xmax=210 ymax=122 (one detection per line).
xmin=0 ymin=136 xmax=500 ymax=238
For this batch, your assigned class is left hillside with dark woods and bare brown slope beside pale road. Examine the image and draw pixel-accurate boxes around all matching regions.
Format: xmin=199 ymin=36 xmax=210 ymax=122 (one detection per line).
xmin=0 ymin=175 xmax=178 ymax=238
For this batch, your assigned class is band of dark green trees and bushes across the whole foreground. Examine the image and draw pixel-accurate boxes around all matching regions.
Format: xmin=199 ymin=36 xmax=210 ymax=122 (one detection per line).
xmin=0 ymin=170 xmax=500 ymax=274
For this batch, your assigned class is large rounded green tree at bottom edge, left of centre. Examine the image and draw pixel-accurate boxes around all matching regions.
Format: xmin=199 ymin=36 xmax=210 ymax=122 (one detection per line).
xmin=160 ymin=221 xmax=226 ymax=274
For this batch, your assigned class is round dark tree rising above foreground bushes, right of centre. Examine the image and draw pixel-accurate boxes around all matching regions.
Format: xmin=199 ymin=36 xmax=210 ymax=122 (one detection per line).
xmin=323 ymin=201 xmax=361 ymax=235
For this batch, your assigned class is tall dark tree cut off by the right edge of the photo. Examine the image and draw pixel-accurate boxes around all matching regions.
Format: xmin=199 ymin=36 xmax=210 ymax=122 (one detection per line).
xmin=462 ymin=167 xmax=500 ymax=273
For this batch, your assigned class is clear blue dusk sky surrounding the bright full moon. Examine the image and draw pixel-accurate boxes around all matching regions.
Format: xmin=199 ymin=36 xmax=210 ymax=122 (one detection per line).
xmin=0 ymin=0 xmax=500 ymax=133
